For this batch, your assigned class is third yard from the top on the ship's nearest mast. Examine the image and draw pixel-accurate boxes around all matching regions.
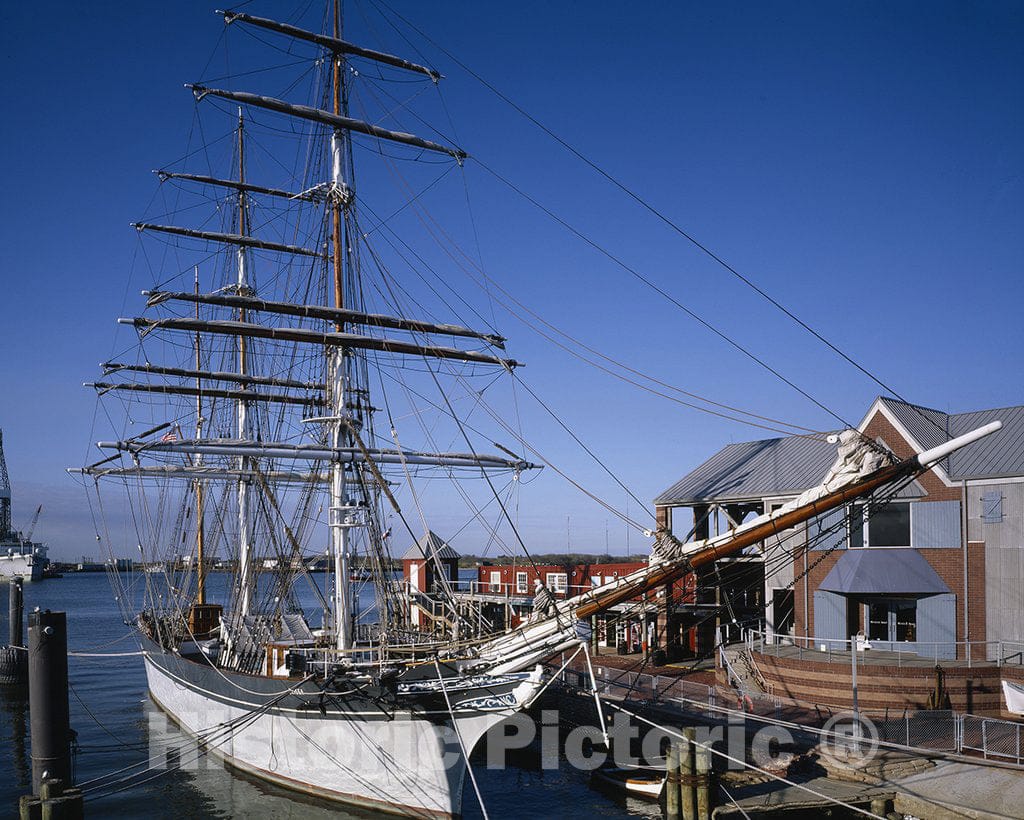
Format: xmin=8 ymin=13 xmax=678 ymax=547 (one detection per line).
xmin=142 ymin=288 xmax=506 ymax=349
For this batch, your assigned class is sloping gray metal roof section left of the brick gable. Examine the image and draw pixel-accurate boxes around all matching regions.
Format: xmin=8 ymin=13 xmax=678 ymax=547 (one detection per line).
xmin=654 ymin=436 xmax=836 ymax=505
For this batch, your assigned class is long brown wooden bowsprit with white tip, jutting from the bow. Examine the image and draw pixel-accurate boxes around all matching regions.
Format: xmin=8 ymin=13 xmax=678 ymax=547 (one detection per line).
xmin=575 ymin=422 xmax=1002 ymax=618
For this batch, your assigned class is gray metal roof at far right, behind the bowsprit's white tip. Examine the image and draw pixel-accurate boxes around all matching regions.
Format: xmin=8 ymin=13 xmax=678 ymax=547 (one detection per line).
xmin=882 ymin=398 xmax=1024 ymax=480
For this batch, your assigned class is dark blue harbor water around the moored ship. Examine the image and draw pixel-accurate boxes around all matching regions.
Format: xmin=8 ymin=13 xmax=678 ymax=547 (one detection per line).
xmin=0 ymin=572 xmax=660 ymax=819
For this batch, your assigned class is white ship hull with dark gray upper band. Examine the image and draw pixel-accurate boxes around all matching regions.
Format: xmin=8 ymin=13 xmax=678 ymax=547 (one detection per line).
xmin=144 ymin=644 xmax=543 ymax=817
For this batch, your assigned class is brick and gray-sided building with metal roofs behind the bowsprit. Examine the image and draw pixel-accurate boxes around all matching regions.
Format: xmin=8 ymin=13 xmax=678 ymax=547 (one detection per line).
xmin=654 ymin=397 xmax=1024 ymax=658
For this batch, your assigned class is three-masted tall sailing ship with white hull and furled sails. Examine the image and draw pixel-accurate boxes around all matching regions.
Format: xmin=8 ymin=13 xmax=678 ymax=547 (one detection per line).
xmin=80 ymin=4 xmax=1003 ymax=816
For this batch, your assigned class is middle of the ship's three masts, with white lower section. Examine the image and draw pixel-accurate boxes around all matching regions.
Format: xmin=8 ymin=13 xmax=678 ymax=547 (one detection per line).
xmin=235 ymin=107 xmax=253 ymax=617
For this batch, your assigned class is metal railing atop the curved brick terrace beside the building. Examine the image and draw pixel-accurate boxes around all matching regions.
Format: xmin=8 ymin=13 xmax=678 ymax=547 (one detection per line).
xmin=743 ymin=630 xmax=1024 ymax=668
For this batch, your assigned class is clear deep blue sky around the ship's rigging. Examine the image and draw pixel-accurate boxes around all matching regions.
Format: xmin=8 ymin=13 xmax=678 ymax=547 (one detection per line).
xmin=0 ymin=0 xmax=1024 ymax=557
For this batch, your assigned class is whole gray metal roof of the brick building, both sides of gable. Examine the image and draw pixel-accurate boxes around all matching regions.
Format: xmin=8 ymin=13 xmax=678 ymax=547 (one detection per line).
xmin=654 ymin=397 xmax=1024 ymax=505
